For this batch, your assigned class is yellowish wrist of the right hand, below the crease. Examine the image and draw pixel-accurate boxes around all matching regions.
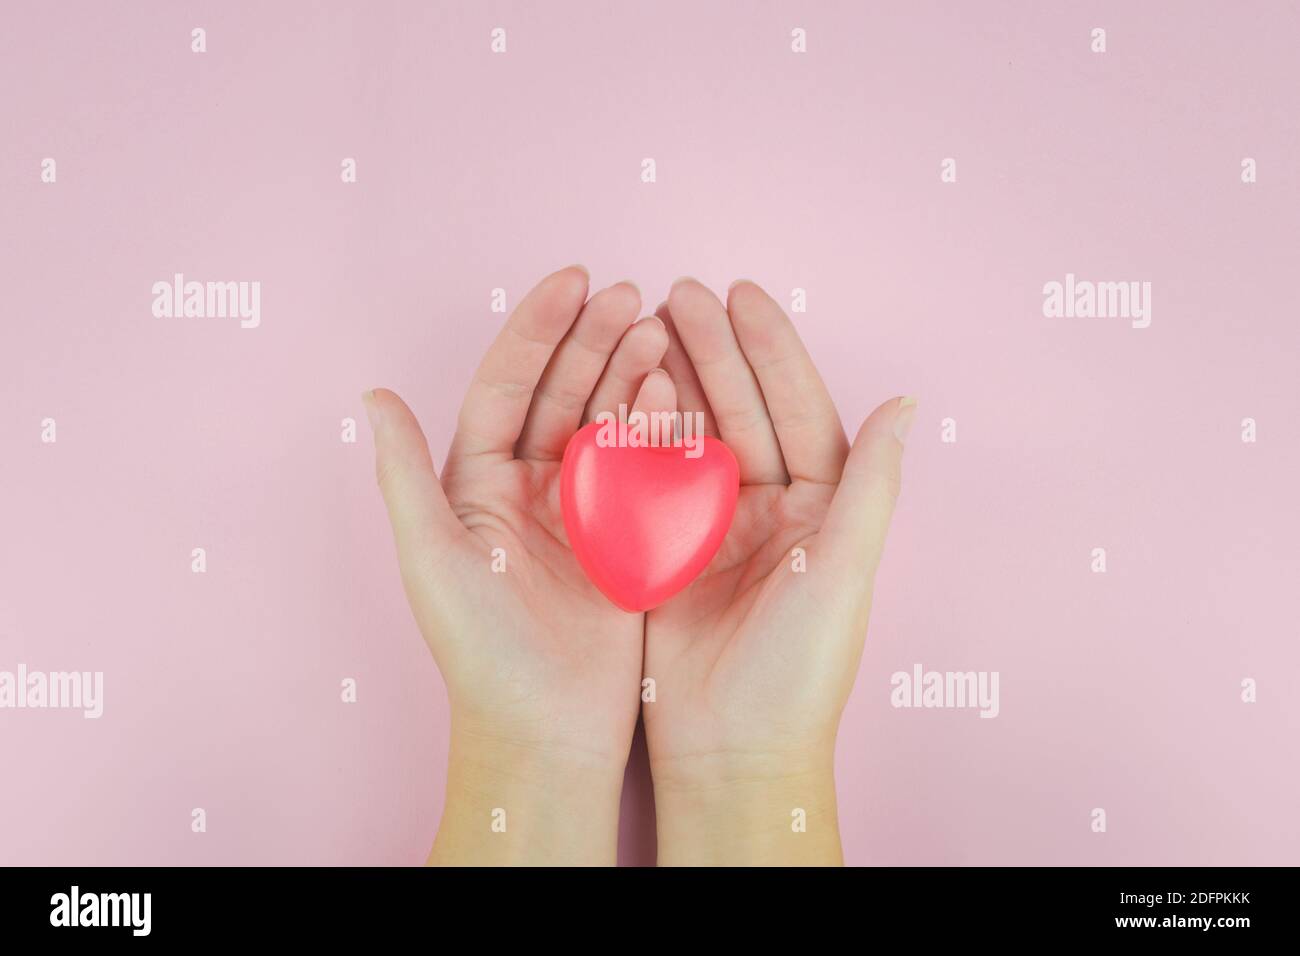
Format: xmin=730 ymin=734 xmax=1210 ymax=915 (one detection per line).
xmin=651 ymin=743 xmax=842 ymax=866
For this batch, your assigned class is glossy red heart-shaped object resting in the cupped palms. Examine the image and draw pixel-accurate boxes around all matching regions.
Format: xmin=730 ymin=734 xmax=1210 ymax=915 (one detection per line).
xmin=560 ymin=421 xmax=740 ymax=611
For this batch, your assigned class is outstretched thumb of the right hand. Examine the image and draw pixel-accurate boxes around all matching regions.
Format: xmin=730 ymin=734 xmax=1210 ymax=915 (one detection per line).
xmin=818 ymin=398 xmax=917 ymax=575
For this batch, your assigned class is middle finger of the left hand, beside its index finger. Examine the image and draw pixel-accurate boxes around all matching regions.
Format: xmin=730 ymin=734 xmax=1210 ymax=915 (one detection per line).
xmin=515 ymin=282 xmax=641 ymax=460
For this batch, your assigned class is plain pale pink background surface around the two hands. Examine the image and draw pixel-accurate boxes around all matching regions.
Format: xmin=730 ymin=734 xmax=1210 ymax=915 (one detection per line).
xmin=0 ymin=0 xmax=1300 ymax=864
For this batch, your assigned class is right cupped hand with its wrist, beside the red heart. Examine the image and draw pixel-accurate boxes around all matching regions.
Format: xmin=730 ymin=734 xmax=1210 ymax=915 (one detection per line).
xmin=644 ymin=280 xmax=915 ymax=864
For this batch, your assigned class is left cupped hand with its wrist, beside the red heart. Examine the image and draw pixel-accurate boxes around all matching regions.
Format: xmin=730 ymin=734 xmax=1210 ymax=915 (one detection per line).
xmin=365 ymin=267 xmax=676 ymax=862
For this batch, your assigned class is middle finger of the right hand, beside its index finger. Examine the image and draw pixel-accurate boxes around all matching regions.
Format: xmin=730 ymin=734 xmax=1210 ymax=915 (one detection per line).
xmin=668 ymin=278 xmax=774 ymax=484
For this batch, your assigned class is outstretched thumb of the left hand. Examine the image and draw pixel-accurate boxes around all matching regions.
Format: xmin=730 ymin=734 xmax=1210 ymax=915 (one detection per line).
xmin=361 ymin=389 xmax=464 ymax=563
